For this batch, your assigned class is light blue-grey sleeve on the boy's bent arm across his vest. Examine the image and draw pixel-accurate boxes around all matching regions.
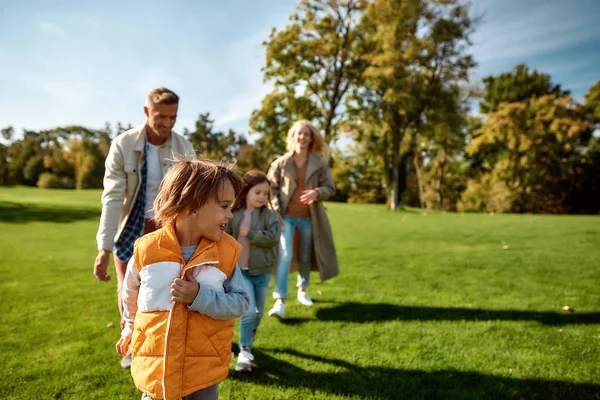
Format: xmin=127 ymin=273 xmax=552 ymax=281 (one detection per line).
xmin=188 ymin=264 xmax=250 ymax=320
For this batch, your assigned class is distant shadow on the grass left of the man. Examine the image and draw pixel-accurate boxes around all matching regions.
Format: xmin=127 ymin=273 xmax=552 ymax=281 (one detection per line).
xmin=0 ymin=201 xmax=100 ymax=224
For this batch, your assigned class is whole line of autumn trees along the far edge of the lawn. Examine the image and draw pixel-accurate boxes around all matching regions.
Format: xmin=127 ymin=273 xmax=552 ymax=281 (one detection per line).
xmin=0 ymin=0 xmax=600 ymax=213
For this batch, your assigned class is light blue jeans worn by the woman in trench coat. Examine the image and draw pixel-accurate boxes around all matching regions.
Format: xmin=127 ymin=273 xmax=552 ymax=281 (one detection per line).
xmin=273 ymin=215 xmax=313 ymax=299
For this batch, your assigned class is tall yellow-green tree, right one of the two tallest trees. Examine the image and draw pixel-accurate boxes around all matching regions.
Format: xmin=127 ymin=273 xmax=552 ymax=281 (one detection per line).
xmin=350 ymin=0 xmax=475 ymax=208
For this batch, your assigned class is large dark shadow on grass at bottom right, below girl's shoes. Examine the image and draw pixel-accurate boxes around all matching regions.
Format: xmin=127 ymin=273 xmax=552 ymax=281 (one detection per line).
xmin=230 ymin=349 xmax=600 ymax=400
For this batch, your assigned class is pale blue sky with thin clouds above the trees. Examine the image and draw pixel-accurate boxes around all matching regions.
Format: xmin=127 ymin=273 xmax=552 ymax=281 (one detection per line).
xmin=0 ymin=0 xmax=600 ymax=141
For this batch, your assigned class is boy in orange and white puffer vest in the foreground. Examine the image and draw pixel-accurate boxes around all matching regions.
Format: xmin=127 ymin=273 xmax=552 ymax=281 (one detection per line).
xmin=116 ymin=158 xmax=249 ymax=400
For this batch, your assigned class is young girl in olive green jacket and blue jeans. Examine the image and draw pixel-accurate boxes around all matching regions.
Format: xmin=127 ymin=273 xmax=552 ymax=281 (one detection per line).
xmin=227 ymin=171 xmax=281 ymax=372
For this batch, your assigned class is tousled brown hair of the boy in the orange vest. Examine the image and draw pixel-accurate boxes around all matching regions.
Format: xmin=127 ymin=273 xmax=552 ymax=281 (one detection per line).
xmin=154 ymin=156 xmax=244 ymax=226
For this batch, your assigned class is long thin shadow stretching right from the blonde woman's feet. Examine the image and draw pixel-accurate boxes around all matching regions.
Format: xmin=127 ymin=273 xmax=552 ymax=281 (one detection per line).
xmin=316 ymin=303 xmax=600 ymax=325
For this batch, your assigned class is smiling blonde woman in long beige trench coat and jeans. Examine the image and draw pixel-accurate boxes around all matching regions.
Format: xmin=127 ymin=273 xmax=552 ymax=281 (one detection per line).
xmin=268 ymin=120 xmax=338 ymax=318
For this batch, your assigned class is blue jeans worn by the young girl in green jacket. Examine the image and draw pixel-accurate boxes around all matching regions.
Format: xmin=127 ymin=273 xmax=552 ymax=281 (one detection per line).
xmin=239 ymin=270 xmax=271 ymax=347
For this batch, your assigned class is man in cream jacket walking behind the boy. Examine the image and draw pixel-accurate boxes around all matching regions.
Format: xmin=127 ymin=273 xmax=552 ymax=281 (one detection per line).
xmin=94 ymin=88 xmax=194 ymax=368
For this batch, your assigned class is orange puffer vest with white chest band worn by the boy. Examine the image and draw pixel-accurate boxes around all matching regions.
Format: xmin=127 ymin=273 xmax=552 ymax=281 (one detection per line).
xmin=131 ymin=225 xmax=241 ymax=399
